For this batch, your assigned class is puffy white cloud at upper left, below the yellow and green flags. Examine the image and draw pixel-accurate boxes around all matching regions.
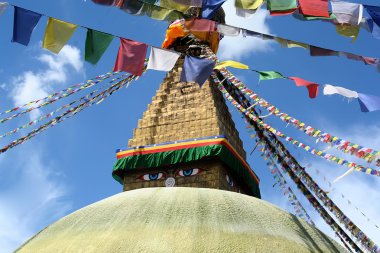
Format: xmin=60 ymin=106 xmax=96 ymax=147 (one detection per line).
xmin=10 ymin=45 xmax=83 ymax=119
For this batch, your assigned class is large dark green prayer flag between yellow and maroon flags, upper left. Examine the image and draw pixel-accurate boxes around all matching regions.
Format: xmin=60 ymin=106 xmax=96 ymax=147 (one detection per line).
xmin=84 ymin=29 xmax=114 ymax=64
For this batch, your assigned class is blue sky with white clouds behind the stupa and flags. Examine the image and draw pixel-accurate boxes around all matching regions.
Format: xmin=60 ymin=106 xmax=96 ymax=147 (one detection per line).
xmin=0 ymin=0 xmax=380 ymax=252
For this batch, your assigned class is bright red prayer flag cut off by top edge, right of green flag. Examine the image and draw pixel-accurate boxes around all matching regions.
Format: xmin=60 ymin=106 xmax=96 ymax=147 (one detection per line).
xmin=298 ymin=0 xmax=330 ymax=18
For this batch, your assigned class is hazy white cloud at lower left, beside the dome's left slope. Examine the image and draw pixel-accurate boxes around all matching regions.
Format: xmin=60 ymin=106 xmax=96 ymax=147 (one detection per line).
xmin=0 ymin=149 xmax=71 ymax=253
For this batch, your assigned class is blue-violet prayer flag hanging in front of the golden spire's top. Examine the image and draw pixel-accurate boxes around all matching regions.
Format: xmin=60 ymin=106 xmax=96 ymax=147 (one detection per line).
xmin=180 ymin=56 xmax=215 ymax=86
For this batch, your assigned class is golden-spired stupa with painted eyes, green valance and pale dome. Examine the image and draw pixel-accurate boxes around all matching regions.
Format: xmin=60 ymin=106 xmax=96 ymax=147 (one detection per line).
xmin=16 ymin=6 xmax=346 ymax=253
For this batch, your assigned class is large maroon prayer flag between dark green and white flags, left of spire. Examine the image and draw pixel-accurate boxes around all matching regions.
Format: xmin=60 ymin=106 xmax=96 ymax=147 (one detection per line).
xmin=113 ymin=38 xmax=148 ymax=76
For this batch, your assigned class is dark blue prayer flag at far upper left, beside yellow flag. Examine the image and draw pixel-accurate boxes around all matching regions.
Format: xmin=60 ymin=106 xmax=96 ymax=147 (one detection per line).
xmin=12 ymin=6 xmax=41 ymax=46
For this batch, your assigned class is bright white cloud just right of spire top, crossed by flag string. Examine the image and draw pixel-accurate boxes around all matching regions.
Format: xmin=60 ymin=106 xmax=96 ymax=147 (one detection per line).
xmin=218 ymin=1 xmax=272 ymax=60
